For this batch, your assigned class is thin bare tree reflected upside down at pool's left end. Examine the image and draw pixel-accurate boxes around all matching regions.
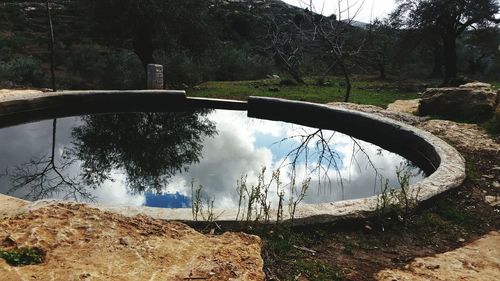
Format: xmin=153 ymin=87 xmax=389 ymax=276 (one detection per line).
xmin=8 ymin=119 xmax=94 ymax=200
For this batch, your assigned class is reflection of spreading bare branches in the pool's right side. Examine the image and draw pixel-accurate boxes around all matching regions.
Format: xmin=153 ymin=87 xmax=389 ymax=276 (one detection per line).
xmin=277 ymin=128 xmax=379 ymax=199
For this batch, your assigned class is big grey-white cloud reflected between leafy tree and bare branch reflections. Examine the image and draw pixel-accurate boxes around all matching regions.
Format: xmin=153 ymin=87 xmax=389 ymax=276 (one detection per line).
xmin=167 ymin=111 xmax=280 ymax=206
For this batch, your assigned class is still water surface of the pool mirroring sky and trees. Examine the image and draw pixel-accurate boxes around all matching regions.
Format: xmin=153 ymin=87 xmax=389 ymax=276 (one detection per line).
xmin=0 ymin=110 xmax=425 ymax=208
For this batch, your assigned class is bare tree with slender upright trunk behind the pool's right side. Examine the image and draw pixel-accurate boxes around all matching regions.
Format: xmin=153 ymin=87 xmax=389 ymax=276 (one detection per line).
xmin=268 ymin=0 xmax=366 ymax=102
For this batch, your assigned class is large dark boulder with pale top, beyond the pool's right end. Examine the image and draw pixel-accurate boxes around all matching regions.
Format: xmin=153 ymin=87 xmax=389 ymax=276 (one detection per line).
xmin=418 ymin=82 xmax=498 ymax=120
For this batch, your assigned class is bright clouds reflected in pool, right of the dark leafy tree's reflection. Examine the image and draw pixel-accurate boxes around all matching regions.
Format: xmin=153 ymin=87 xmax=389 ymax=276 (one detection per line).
xmin=162 ymin=111 xmax=424 ymax=207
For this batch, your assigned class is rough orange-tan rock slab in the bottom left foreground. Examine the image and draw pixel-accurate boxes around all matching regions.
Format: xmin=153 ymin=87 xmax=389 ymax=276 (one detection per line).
xmin=0 ymin=203 xmax=265 ymax=281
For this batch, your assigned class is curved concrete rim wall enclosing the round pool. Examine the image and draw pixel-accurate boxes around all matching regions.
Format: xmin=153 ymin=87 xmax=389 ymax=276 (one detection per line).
xmin=0 ymin=91 xmax=465 ymax=223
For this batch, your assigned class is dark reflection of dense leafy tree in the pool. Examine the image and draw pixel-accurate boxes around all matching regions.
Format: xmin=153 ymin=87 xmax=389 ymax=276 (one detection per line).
xmin=72 ymin=111 xmax=216 ymax=192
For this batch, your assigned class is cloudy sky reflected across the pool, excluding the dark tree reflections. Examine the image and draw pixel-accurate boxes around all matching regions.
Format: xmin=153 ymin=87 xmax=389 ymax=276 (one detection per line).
xmin=0 ymin=110 xmax=422 ymax=208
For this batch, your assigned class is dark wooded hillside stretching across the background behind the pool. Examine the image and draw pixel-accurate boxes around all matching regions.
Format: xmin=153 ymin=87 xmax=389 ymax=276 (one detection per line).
xmin=0 ymin=0 xmax=500 ymax=89
